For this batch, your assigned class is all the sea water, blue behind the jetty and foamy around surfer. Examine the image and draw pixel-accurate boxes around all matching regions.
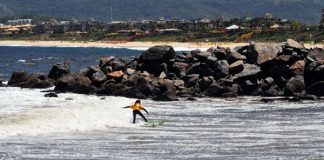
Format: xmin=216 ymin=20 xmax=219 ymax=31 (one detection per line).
xmin=0 ymin=46 xmax=324 ymax=160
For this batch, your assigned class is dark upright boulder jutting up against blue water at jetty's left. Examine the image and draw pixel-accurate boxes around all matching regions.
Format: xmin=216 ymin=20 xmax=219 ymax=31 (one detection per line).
xmin=48 ymin=63 xmax=71 ymax=80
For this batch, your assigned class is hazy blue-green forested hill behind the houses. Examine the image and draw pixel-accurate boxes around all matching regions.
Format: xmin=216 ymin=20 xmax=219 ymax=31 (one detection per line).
xmin=0 ymin=0 xmax=324 ymax=24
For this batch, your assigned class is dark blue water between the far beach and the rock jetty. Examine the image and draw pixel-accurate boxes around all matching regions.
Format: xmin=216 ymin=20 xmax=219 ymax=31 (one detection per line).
xmin=0 ymin=46 xmax=143 ymax=80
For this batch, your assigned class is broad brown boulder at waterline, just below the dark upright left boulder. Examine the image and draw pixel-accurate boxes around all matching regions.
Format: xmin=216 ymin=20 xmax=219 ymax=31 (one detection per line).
xmin=54 ymin=74 xmax=91 ymax=94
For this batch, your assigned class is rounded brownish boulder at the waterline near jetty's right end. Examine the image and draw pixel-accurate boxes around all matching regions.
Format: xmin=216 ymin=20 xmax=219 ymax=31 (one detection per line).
xmin=285 ymin=76 xmax=305 ymax=95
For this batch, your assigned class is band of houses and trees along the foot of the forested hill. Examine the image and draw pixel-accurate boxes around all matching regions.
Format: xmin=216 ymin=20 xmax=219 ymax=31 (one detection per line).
xmin=0 ymin=12 xmax=324 ymax=35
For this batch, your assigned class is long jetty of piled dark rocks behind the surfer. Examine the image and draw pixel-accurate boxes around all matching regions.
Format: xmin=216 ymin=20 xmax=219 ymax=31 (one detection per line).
xmin=8 ymin=39 xmax=324 ymax=101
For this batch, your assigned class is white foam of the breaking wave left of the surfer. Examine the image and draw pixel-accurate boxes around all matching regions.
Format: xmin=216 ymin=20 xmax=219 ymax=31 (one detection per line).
xmin=0 ymin=88 xmax=142 ymax=138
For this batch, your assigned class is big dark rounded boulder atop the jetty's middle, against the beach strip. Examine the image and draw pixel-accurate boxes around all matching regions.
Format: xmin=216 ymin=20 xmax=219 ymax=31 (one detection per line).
xmin=139 ymin=45 xmax=176 ymax=63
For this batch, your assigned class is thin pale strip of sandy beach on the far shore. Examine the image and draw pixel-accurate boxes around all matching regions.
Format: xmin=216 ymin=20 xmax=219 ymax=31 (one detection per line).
xmin=0 ymin=40 xmax=324 ymax=50
